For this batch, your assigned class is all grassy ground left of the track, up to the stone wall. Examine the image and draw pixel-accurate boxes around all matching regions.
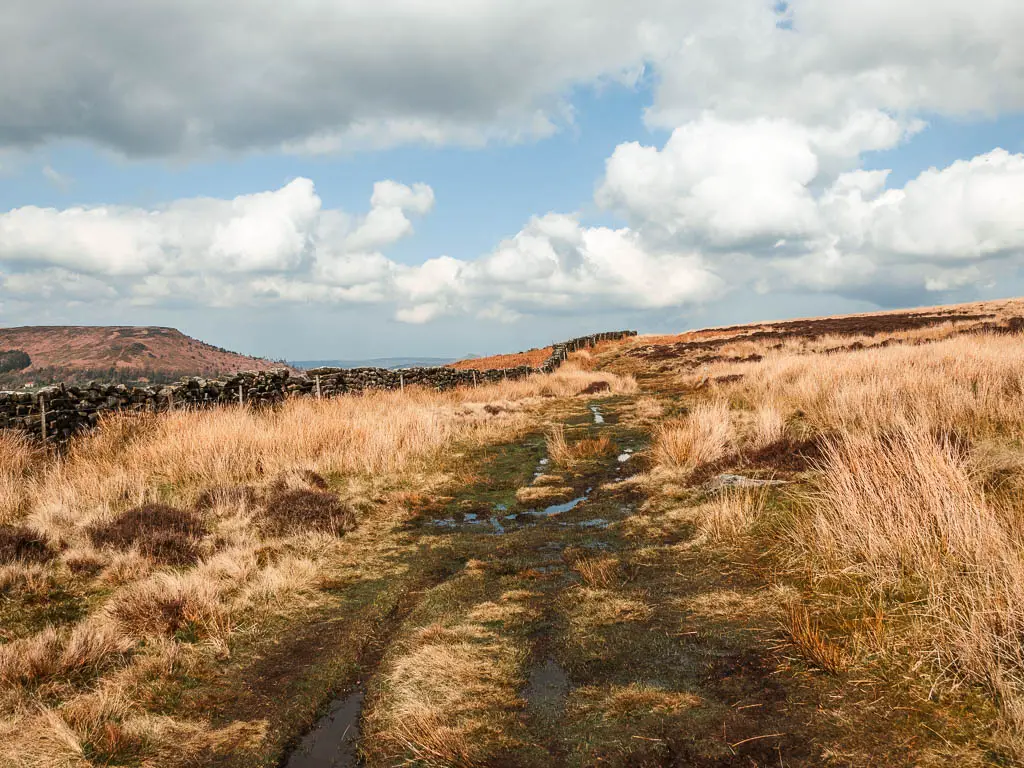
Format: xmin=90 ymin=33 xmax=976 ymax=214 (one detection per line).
xmin=0 ymin=366 xmax=635 ymax=766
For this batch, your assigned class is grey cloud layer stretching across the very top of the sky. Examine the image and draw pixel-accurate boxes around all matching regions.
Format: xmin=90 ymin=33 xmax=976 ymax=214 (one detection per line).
xmin=0 ymin=0 xmax=1024 ymax=156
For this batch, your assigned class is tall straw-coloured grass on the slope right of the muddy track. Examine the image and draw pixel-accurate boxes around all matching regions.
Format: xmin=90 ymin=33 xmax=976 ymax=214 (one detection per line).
xmin=654 ymin=329 xmax=1024 ymax=754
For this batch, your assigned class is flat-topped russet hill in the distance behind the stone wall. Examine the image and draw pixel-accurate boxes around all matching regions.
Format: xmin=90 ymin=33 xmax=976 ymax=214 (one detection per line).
xmin=0 ymin=326 xmax=283 ymax=389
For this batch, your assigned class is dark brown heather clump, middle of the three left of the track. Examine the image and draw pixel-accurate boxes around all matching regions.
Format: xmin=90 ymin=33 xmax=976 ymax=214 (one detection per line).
xmin=89 ymin=504 xmax=206 ymax=565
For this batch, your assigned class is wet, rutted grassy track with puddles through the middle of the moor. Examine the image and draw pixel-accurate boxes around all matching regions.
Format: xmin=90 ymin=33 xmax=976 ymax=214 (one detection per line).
xmin=280 ymin=397 xmax=983 ymax=768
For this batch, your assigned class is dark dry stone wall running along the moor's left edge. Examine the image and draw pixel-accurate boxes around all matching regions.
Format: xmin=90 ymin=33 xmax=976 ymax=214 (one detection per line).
xmin=0 ymin=331 xmax=636 ymax=442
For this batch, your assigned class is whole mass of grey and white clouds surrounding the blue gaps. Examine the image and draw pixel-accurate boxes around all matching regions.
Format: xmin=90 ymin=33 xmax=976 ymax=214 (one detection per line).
xmin=0 ymin=0 xmax=1024 ymax=324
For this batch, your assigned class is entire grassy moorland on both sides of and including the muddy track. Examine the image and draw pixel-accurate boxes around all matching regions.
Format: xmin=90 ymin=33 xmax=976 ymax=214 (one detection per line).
xmin=6 ymin=302 xmax=1024 ymax=768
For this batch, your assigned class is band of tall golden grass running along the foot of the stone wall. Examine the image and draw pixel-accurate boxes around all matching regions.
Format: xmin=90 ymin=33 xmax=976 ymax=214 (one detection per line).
xmin=19 ymin=361 xmax=636 ymax=542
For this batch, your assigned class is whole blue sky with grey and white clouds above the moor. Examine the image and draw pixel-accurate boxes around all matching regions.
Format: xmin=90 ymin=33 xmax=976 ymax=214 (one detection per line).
xmin=0 ymin=0 xmax=1024 ymax=359
